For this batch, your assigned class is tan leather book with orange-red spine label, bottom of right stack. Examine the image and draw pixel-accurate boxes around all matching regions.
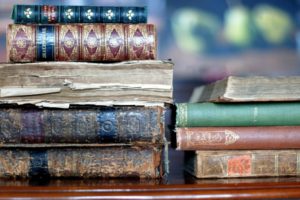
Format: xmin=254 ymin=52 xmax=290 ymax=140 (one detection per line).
xmin=185 ymin=150 xmax=300 ymax=178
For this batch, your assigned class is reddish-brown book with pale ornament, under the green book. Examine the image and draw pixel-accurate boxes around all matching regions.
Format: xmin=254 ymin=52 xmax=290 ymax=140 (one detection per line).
xmin=176 ymin=126 xmax=300 ymax=150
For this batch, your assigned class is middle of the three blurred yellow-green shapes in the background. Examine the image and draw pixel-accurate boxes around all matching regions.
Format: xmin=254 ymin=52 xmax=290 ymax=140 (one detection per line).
xmin=224 ymin=6 xmax=254 ymax=47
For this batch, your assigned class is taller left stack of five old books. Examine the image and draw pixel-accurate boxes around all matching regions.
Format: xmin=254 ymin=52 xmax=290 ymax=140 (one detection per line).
xmin=0 ymin=5 xmax=173 ymax=178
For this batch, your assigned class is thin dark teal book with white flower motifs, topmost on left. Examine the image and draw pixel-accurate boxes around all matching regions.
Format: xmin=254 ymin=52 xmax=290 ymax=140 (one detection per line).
xmin=11 ymin=5 xmax=147 ymax=24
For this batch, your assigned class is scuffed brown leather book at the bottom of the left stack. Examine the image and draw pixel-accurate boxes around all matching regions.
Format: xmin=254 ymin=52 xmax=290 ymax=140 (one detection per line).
xmin=0 ymin=147 xmax=163 ymax=178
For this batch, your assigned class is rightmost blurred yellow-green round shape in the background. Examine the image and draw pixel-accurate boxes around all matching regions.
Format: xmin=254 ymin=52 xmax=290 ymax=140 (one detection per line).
xmin=253 ymin=4 xmax=294 ymax=44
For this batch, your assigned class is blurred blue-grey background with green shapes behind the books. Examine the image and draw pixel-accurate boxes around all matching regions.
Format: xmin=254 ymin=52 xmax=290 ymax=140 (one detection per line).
xmin=0 ymin=0 xmax=300 ymax=102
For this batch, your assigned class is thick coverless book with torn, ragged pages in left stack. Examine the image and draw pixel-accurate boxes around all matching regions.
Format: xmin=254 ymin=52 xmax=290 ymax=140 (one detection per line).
xmin=0 ymin=60 xmax=173 ymax=108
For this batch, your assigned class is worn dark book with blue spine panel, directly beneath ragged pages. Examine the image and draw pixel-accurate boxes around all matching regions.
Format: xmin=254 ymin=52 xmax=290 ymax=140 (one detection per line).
xmin=0 ymin=107 xmax=164 ymax=144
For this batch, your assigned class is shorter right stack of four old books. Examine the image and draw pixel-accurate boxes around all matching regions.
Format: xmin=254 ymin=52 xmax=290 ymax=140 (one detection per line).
xmin=176 ymin=76 xmax=300 ymax=178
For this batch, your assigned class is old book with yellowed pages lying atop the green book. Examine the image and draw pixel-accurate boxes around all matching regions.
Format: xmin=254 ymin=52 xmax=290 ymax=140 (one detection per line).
xmin=190 ymin=76 xmax=300 ymax=103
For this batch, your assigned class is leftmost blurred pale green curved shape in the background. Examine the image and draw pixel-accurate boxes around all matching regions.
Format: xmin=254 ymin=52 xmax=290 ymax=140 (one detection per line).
xmin=171 ymin=8 xmax=221 ymax=53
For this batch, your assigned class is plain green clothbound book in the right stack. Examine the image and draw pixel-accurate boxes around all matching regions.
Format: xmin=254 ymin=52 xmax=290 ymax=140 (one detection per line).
xmin=176 ymin=102 xmax=300 ymax=127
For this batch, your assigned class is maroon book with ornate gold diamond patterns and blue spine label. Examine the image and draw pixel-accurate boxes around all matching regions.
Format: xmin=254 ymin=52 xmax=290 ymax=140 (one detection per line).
xmin=6 ymin=24 xmax=157 ymax=62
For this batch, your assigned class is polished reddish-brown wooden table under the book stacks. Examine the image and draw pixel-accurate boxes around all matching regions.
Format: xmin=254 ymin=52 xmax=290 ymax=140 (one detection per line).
xmin=0 ymin=149 xmax=300 ymax=199
